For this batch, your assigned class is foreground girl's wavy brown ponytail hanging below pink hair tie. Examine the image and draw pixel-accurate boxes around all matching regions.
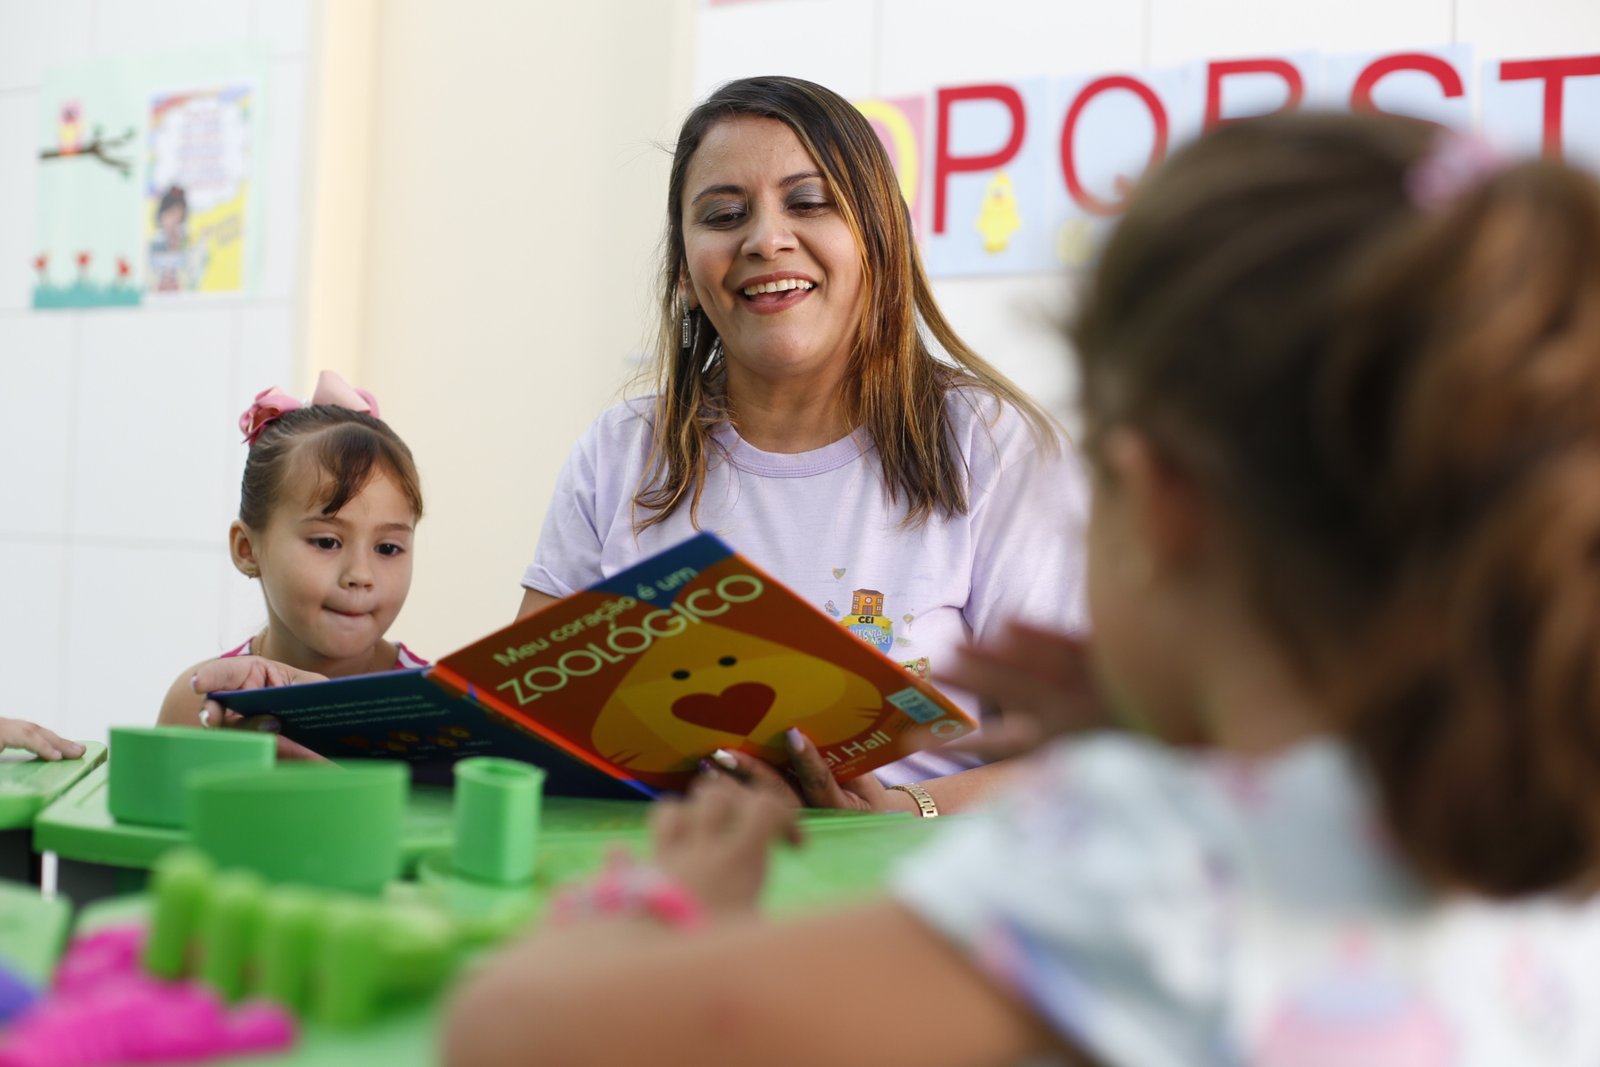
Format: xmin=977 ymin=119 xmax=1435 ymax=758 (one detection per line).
xmin=1328 ymin=156 xmax=1600 ymax=896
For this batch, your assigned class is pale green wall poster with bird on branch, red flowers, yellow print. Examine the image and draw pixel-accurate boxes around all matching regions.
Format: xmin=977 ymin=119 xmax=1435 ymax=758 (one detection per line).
xmin=32 ymin=46 xmax=267 ymax=309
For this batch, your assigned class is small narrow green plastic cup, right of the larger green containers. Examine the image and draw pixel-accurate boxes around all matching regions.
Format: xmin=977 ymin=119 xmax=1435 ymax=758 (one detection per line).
xmin=451 ymin=757 xmax=544 ymax=886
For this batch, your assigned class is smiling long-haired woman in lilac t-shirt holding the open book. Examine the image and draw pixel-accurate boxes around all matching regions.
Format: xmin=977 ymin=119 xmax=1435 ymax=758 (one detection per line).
xmin=522 ymin=77 xmax=1086 ymax=813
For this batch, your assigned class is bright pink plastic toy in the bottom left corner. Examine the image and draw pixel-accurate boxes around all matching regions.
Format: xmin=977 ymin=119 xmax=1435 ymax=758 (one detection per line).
xmin=0 ymin=928 xmax=294 ymax=1067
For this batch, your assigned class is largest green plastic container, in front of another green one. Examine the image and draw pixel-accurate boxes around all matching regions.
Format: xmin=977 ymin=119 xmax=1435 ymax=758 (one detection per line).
xmin=189 ymin=763 xmax=410 ymax=894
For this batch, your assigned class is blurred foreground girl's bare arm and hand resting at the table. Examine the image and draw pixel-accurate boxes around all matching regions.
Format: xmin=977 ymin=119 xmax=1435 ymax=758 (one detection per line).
xmin=445 ymin=781 xmax=1081 ymax=1067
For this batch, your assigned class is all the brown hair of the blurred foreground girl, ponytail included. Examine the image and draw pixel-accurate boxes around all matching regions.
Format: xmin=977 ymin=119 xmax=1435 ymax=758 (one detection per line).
xmin=1074 ymin=115 xmax=1600 ymax=896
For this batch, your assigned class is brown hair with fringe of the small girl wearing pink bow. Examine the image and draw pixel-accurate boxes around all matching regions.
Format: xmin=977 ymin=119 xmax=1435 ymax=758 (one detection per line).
xmin=238 ymin=403 xmax=422 ymax=530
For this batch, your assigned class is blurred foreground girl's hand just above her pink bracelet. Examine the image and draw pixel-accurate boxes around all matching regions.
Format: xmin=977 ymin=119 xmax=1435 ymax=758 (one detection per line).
xmin=650 ymin=776 xmax=800 ymax=917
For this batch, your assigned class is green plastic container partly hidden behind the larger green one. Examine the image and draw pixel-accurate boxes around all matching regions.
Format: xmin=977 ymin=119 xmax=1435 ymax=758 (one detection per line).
xmin=106 ymin=726 xmax=277 ymax=829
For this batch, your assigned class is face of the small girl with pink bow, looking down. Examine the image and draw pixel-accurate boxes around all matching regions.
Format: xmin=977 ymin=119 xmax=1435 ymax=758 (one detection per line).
xmin=235 ymin=462 xmax=416 ymax=673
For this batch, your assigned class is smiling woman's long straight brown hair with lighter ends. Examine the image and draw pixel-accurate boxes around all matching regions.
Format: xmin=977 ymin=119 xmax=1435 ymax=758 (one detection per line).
xmin=634 ymin=77 xmax=1058 ymax=530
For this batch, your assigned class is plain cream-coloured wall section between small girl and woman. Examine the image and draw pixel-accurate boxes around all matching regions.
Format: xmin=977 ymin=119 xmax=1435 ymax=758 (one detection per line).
xmin=312 ymin=0 xmax=694 ymax=656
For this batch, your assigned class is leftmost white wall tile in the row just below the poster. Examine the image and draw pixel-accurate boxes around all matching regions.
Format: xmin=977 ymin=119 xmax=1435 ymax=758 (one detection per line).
xmin=0 ymin=312 xmax=77 ymax=537
